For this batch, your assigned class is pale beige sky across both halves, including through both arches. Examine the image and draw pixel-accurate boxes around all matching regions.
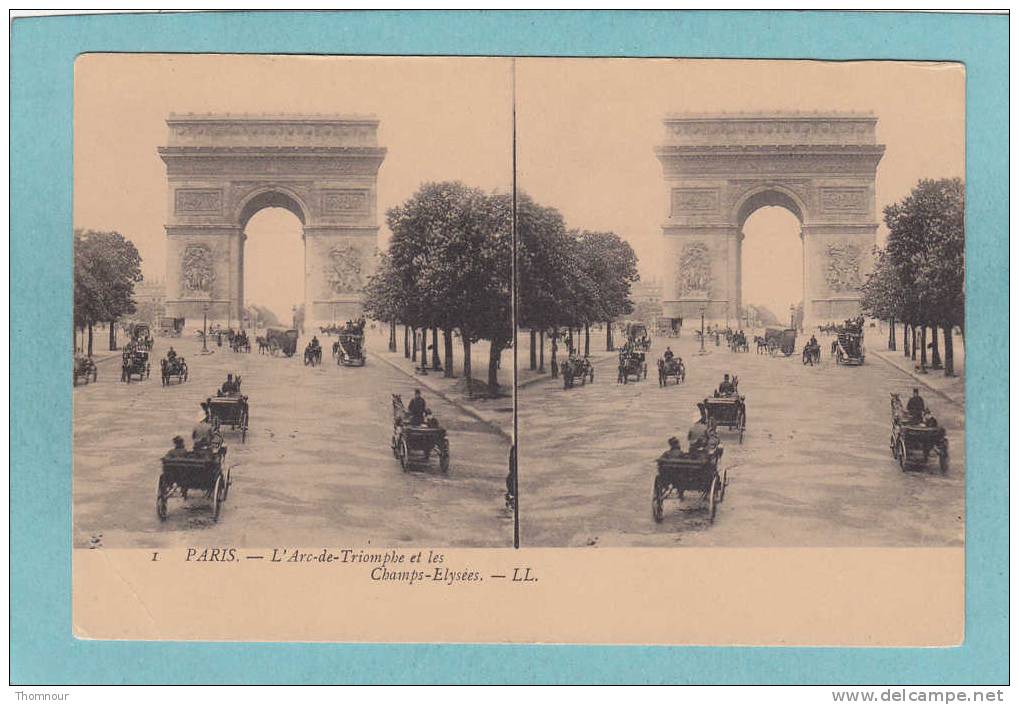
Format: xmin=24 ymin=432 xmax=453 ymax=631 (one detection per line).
xmin=74 ymin=54 xmax=965 ymax=316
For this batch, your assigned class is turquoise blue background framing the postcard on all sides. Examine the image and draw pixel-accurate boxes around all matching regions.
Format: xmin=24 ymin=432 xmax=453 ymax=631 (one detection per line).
xmin=10 ymin=12 xmax=1009 ymax=684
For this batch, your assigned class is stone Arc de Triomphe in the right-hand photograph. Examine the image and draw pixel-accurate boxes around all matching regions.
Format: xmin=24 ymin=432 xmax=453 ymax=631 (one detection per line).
xmin=655 ymin=113 xmax=884 ymax=326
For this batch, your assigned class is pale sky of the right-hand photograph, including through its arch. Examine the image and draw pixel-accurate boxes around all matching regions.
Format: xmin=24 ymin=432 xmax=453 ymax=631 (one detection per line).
xmin=517 ymin=59 xmax=965 ymax=317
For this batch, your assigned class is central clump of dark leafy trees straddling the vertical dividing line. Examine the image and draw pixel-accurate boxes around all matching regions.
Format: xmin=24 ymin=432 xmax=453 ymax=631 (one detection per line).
xmin=364 ymin=181 xmax=638 ymax=394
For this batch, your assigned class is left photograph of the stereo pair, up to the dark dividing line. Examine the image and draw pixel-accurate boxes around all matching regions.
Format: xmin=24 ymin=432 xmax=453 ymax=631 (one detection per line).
xmin=72 ymin=54 xmax=517 ymax=551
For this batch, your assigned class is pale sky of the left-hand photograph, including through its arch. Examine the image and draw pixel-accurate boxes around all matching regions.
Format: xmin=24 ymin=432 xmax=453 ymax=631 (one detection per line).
xmin=74 ymin=54 xmax=513 ymax=320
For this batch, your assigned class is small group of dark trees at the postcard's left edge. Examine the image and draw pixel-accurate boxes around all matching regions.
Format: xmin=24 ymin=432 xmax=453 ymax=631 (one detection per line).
xmin=73 ymin=229 xmax=142 ymax=356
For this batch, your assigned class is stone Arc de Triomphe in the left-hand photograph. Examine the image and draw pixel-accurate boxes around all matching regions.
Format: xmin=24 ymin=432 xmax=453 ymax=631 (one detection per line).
xmin=159 ymin=114 xmax=385 ymax=324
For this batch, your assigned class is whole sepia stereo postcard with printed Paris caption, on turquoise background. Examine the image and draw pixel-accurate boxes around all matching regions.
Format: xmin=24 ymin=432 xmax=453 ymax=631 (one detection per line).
xmin=72 ymin=54 xmax=966 ymax=646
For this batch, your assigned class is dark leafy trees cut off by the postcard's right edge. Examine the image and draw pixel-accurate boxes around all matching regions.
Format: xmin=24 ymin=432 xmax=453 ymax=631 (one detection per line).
xmin=861 ymin=178 xmax=965 ymax=376
